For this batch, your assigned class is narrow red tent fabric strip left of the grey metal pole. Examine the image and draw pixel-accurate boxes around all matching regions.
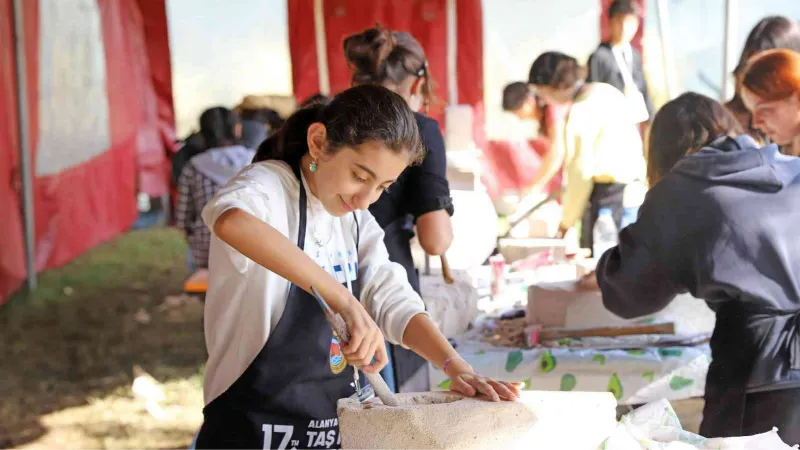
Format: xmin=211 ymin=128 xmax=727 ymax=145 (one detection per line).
xmin=0 ymin=0 xmax=25 ymax=303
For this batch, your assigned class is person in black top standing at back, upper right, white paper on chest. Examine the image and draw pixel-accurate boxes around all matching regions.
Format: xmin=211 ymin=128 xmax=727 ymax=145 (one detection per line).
xmin=586 ymin=0 xmax=654 ymax=122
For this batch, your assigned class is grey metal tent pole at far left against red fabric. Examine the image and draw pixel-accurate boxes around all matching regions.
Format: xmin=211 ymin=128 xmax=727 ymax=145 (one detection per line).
xmin=12 ymin=0 xmax=36 ymax=291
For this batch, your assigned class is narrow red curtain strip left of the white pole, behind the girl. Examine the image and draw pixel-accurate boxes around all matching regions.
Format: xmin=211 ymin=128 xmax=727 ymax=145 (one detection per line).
xmin=287 ymin=0 xmax=319 ymax=103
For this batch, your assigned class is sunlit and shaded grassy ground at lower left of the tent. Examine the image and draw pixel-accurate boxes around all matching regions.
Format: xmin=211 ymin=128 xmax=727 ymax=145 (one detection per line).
xmin=0 ymin=229 xmax=205 ymax=450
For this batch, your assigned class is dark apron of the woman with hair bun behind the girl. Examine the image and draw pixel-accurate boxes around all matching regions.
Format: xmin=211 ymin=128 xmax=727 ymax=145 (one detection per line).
xmin=383 ymin=215 xmax=430 ymax=392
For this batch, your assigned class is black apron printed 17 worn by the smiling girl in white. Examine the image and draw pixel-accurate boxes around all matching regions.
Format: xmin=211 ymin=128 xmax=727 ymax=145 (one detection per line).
xmin=197 ymin=163 xmax=366 ymax=450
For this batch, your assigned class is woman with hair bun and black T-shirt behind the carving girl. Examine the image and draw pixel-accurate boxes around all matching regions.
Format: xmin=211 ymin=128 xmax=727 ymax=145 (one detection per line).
xmin=344 ymin=25 xmax=453 ymax=392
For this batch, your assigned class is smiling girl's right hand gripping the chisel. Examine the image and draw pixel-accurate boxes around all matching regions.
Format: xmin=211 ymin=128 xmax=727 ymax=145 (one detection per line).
xmin=338 ymin=296 xmax=389 ymax=373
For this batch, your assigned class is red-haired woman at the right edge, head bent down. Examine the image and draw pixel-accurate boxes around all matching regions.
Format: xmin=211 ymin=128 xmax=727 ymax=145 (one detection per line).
xmin=740 ymin=49 xmax=800 ymax=156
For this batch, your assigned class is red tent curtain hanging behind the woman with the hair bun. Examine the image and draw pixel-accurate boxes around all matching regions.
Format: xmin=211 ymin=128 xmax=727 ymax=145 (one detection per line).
xmin=288 ymin=0 xmax=483 ymax=132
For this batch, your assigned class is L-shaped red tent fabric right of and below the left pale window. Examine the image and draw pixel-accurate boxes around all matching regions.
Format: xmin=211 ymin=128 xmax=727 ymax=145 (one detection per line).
xmin=32 ymin=0 xmax=139 ymax=270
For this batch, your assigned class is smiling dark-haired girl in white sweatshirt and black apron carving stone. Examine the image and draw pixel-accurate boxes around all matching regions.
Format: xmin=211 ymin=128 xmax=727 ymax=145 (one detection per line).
xmin=197 ymin=85 xmax=519 ymax=450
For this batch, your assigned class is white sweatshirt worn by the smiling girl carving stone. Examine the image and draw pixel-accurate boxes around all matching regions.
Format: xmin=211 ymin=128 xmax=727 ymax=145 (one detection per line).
xmin=203 ymin=161 xmax=425 ymax=404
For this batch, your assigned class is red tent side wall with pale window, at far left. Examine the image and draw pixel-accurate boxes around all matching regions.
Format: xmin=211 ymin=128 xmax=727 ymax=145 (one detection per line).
xmin=0 ymin=0 xmax=174 ymax=303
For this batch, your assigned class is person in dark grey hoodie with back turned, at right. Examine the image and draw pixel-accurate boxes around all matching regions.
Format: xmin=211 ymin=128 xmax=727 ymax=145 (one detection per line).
xmin=596 ymin=93 xmax=800 ymax=445
